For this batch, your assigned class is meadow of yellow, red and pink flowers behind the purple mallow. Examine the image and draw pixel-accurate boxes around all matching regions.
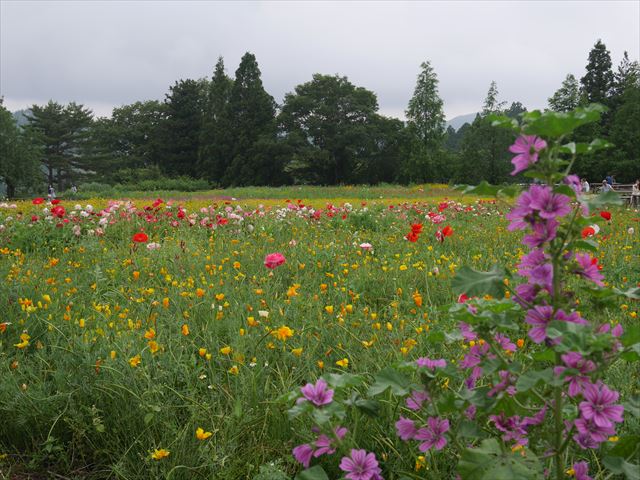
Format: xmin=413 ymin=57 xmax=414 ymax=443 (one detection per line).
xmin=0 ymin=186 xmax=640 ymax=480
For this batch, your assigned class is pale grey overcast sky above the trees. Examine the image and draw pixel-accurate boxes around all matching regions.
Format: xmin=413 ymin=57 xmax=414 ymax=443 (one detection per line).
xmin=0 ymin=0 xmax=640 ymax=118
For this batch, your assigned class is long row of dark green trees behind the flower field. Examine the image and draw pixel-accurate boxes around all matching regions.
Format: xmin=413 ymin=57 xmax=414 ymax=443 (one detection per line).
xmin=0 ymin=41 xmax=640 ymax=196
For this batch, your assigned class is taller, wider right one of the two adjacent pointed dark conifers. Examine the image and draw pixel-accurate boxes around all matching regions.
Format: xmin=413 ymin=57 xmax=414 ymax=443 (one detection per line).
xmin=222 ymin=52 xmax=278 ymax=186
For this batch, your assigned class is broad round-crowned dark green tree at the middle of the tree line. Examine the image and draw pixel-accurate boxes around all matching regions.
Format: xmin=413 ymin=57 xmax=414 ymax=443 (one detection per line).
xmin=279 ymin=74 xmax=380 ymax=185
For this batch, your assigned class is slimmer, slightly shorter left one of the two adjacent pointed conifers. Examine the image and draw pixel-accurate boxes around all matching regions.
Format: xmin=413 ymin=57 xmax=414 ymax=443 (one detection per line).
xmin=198 ymin=57 xmax=233 ymax=182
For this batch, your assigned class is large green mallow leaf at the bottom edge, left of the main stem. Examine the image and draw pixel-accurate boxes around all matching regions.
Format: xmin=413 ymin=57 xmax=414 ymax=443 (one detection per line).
xmin=458 ymin=438 xmax=543 ymax=480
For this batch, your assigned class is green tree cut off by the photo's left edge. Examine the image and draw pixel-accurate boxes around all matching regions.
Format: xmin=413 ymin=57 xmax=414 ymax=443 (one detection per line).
xmin=0 ymin=97 xmax=43 ymax=198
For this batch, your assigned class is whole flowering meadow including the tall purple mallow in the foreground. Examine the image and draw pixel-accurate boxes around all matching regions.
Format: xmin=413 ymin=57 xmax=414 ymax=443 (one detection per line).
xmin=0 ymin=106 xmax=640 ymax=480
